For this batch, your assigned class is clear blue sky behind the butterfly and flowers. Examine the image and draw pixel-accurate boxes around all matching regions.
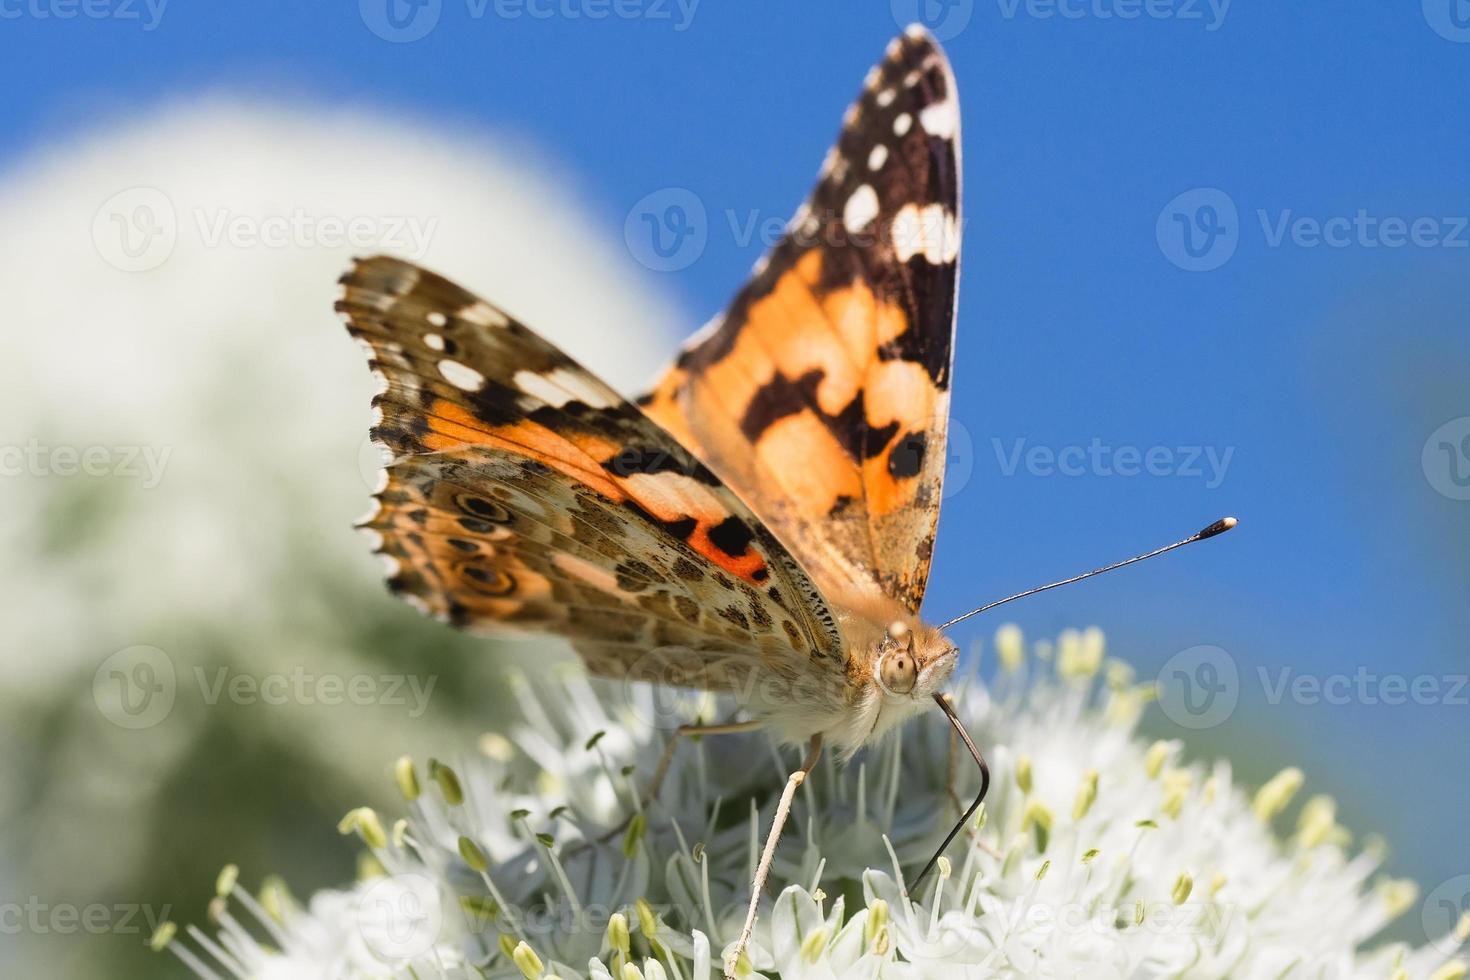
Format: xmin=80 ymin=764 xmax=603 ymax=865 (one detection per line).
xmin=0 ymin=0 xmax=1470 ymax=922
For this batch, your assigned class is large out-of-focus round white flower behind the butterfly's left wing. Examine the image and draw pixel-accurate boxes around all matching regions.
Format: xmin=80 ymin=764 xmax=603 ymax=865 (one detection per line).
xmin=0 ymin=94 xmax=694 ymax=976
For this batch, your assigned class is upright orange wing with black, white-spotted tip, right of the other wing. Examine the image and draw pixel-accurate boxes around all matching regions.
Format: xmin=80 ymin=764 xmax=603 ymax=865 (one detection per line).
xmin=639 ymin=29 xmax=960 ymax=611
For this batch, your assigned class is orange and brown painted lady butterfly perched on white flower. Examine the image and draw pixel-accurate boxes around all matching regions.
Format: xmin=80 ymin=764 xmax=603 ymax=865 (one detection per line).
xmin=337 ymin=28 xmax=1228 ymax=975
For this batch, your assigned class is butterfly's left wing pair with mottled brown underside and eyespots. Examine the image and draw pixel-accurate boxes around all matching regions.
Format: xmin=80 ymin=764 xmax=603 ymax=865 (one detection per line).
xmin=338 ymin=257 xmax=845 ymax=691
